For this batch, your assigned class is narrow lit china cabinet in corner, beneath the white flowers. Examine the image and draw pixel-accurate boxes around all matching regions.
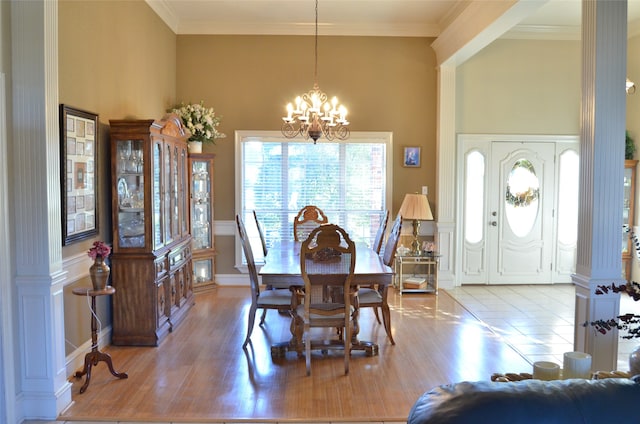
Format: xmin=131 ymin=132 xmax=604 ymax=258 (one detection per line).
xmin=189 ymin=153 xmax=216 ymax=291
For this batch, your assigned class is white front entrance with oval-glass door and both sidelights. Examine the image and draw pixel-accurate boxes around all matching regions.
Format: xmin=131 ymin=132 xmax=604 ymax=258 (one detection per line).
xmin=457 ymin=135 xmax=578 ymax=284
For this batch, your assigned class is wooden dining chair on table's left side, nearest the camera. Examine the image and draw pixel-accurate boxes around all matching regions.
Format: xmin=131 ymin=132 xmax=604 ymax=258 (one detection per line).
xmin=236 ymin=215 xmax=292 ymax=348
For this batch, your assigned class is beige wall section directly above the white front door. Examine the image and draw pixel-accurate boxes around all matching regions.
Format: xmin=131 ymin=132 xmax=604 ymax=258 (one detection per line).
xmin=456 ymin=40 xmax=581 ymax=135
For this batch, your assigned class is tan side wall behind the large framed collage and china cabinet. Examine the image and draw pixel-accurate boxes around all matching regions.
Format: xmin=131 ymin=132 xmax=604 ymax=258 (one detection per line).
xmin=58 ymin=0 xmax=176 ymax=353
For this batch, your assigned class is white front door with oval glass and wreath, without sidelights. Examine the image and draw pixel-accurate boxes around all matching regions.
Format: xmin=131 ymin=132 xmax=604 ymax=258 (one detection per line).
xmin=487 ymin=142 xmax=555 ymax=284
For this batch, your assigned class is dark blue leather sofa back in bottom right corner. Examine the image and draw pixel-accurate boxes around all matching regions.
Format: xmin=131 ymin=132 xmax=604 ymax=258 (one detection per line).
xmin=407 ymin=376 xmax=640 ymax=424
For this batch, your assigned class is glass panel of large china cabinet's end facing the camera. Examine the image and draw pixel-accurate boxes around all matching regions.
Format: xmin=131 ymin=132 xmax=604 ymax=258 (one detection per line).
xmin=115 ymin=140 xmax=145 ymax=248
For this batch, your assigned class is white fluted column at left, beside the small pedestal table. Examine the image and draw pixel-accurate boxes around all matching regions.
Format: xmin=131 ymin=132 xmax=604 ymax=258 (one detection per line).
xmin=10 ymin=0 xmax=71 ymax=420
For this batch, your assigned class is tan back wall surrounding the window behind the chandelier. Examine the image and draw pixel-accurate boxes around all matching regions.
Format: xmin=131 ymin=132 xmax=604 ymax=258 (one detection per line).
xmin=177 ymin=35 xmax=437 ymax=274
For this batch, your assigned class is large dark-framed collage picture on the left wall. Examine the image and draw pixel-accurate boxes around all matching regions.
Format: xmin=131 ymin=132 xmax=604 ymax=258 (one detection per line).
xmin=60 ymin=105 xmax=98 ymax=246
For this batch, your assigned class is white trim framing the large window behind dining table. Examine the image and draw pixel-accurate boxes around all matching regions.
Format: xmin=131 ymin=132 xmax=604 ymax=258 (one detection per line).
xmin=234 ymin=130 xmax=393 ymax=273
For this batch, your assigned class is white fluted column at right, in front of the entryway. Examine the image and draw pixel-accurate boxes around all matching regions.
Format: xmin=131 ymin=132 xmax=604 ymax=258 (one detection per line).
xmin=573 ymin=0 xmax=627 ymax=370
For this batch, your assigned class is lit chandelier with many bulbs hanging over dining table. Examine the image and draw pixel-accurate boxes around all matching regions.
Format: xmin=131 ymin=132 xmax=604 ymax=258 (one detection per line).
xmin=282 ymin=0 xmax=349 ymax=144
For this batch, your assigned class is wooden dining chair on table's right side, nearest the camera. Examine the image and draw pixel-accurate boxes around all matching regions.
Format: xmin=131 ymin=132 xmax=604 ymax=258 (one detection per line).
xmin=358 ymin=215 xmax=402 ymax=345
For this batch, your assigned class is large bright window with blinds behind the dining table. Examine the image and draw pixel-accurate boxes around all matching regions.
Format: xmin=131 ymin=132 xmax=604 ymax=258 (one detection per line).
xmin=236 ymin=131 xmax=391 ymax=264
